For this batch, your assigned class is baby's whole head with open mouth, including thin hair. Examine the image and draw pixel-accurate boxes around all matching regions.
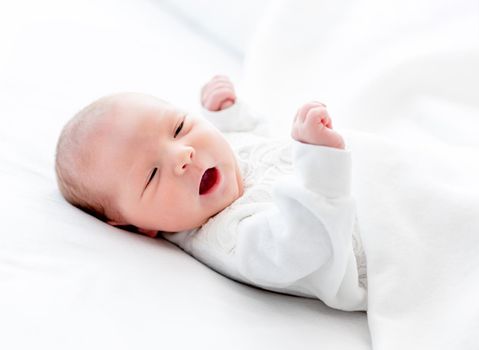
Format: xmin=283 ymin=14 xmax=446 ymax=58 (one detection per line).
xmin=55 ymin=93 xmax=243 ymax=236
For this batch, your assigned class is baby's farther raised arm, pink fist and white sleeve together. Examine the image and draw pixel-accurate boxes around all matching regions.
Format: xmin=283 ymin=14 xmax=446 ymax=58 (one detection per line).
xmin=201 ymin=75 xmax=264 ymax=132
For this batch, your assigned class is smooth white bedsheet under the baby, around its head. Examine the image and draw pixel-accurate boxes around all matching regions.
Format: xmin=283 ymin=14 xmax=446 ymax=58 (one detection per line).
xmin=0 ymin=0 xmax=370 ymax=350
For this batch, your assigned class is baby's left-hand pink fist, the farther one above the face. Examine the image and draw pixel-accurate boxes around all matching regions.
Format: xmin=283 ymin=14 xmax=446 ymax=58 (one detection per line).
xmin=201 ymin=75 xmax=236 ymax=111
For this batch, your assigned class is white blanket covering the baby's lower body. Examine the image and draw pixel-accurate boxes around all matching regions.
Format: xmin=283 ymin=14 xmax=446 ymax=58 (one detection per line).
xmin=349 ymin=130 xmax=479 ymax=349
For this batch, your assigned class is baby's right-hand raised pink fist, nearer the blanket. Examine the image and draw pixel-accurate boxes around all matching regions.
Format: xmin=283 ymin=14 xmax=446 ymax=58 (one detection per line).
xmin=291 ymin=101 xmax=344 ymax=149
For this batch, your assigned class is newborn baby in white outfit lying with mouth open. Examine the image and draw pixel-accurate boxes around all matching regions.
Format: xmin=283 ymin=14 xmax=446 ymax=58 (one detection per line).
xmin=56 ymin=76 xmax=366 ymax=310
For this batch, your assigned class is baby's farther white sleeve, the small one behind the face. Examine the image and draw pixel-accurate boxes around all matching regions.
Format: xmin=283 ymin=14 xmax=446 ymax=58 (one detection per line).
xmin=202 ymin=99 xmax=268 ymax=136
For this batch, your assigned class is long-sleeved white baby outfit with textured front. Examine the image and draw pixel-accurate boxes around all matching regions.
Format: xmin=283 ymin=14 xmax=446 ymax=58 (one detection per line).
xmin=163 ymin=101 xmax=367 ymax=310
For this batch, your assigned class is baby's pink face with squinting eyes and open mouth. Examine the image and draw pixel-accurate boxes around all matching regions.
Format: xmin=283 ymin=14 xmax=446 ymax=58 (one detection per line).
xmin=96 ymin=94 xmax=243 ymax=236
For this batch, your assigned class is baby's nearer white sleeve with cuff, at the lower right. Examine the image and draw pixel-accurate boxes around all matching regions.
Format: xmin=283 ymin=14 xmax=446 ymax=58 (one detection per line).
xmin=235 ymin=141 xmax=364 ymax=310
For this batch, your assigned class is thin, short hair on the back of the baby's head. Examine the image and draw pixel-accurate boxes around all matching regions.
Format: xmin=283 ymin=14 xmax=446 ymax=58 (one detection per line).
xmin=55 ymin=96 xmax=123 ymax=222
